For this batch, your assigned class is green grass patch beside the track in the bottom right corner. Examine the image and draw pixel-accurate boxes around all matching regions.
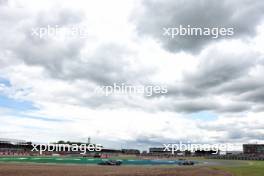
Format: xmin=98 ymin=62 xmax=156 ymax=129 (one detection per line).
xmin=212 ymin=161 xmax=264 ymax=176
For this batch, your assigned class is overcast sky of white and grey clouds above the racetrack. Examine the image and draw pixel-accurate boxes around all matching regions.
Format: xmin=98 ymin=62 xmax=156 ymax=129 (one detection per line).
xmin=0 ymin=0 xmax=264 ymax=148
